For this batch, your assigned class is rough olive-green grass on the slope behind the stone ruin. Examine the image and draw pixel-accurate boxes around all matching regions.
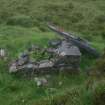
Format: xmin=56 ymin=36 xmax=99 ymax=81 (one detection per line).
xmin=0 ymin=0 xmax=105 ymax=36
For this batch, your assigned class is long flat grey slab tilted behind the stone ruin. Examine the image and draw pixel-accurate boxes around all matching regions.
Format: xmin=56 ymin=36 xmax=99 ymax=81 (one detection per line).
xmin=48 ymin=24 xmax=100 ymax=57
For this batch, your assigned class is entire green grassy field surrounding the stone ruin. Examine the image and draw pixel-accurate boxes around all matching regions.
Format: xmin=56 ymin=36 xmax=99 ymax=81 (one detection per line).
xmin=0 ymin=0 xmax=105 ymax=105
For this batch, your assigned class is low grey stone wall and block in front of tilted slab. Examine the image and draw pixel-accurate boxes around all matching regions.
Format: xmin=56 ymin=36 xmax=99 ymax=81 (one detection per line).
xmin=9 ymin=41 xmax=81 ymax=73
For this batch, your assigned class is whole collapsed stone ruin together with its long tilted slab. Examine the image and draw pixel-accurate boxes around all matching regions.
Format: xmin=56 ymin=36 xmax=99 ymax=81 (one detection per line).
xmin=9 ymin=25 xmax=98 ymax=75
